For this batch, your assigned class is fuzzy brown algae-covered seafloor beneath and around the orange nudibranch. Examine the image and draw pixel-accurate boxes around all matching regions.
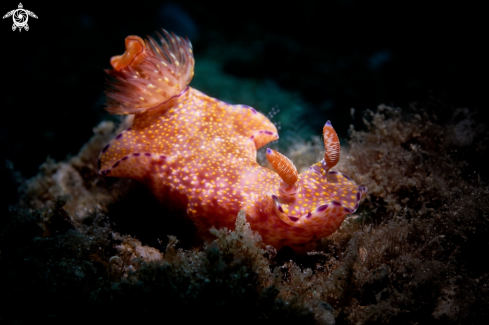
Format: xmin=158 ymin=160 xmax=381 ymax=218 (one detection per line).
xmin=0 ymin=105 xmax=489 ymax=324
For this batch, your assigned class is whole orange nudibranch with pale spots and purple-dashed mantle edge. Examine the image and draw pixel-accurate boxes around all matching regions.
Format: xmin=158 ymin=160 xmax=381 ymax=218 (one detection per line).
xmin=98 ymin=30 xmax=367 ymax=249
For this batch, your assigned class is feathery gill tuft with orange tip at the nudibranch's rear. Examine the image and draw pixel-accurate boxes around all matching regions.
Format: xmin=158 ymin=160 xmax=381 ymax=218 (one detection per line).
xmin=106 ymin=30 xmax=194 ymax=115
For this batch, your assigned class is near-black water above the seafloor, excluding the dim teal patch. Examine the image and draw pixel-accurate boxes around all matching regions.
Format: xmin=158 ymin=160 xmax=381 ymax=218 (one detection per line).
xmin=0 ymin=0 xmax=480 ymax=203
